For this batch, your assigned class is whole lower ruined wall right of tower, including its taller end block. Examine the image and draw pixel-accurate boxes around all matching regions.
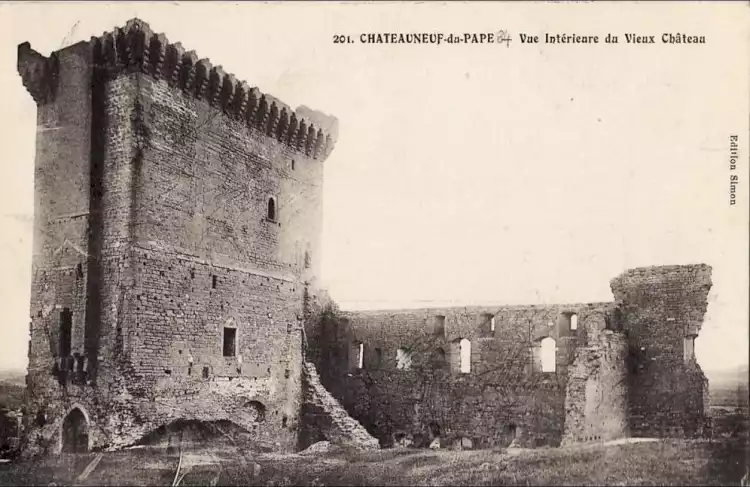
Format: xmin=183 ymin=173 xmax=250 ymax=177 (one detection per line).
xmin=307 ymin=265 xmax=710 ymax=448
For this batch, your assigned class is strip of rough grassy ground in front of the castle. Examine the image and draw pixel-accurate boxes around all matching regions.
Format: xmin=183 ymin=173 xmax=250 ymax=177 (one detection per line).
xmin=0 ymin=440 xmax=748 ymax=486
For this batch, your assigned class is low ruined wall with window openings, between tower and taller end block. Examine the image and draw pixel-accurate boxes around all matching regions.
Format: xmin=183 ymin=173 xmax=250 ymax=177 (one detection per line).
xmin=310 ymin=303 xmax=609 ymax=448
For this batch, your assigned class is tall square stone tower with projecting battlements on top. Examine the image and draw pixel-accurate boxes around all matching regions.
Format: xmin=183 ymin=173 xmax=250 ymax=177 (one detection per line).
xmin=18 ymin=19 xmax=337 ymax=452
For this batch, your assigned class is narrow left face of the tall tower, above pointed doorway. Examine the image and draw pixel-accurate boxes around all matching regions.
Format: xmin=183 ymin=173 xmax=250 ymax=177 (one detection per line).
xmin=18 ymin=39 xmax=110 ymax=458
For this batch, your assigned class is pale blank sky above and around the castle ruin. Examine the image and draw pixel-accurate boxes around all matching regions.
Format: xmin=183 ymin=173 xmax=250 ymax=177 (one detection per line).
xmin=0 ymin=2 xmax=750 ymax=369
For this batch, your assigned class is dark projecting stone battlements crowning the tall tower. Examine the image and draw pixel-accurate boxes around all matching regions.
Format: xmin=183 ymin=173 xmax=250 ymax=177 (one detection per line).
xmin=18 ymin=19 xmax=338 ymax=159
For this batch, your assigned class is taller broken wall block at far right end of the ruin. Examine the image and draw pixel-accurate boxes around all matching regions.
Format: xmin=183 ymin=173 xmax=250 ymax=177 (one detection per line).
xmin=611 ymin=264 xmax=711 ymax=436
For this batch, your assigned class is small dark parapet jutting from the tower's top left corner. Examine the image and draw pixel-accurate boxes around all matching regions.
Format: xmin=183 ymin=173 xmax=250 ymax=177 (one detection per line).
xmin=17 ymin=42 xmax=60 ymax=105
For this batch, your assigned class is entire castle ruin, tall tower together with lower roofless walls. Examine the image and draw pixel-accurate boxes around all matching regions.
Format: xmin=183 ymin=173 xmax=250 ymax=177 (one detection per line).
xmin=18 ymin=19 xmax=711 ymax=453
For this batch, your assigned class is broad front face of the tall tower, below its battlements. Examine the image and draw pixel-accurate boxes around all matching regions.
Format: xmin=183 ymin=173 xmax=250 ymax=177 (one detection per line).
xmin=103 ymin=66 xmax=320 ymax=449
